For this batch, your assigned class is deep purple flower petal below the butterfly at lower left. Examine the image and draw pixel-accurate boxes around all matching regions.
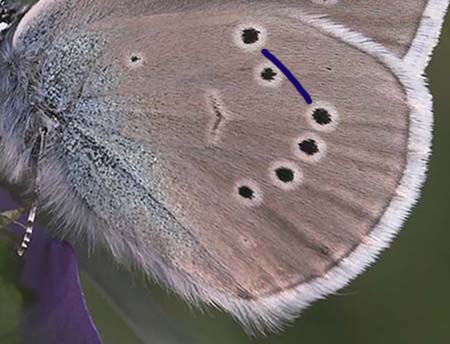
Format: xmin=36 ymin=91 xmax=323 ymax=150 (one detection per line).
xmin=0 ymin=190 xmax=101 ymax=344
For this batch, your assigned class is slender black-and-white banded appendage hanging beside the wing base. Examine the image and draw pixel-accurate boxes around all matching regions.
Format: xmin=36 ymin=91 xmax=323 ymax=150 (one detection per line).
xmin=17 ymin=128 xmax=47 ymax=257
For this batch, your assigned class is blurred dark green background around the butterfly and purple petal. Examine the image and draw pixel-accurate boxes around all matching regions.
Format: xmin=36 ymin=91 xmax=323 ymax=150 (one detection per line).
xmin=0 ymin=1 xmax=450 ymax=344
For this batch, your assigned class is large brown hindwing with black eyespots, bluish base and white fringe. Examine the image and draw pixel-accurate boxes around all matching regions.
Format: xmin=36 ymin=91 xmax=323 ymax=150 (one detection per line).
xmin=12 ymin=0 xmax=448 ymax=330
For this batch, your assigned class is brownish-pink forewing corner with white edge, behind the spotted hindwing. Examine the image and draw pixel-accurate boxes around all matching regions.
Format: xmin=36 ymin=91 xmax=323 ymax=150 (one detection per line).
xmin=289 ymin=0 xmax=449 ymax=71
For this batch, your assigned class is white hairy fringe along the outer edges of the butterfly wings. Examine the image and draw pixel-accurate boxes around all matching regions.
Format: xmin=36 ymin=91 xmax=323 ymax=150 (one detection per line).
xmin=6 ymin=0 xmax=450 ymax=333
